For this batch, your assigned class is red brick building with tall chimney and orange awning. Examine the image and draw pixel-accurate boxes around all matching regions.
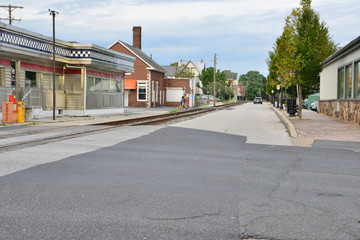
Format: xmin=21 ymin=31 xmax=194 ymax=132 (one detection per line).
xmin=109 ymin=26 xmax=166 ymax=107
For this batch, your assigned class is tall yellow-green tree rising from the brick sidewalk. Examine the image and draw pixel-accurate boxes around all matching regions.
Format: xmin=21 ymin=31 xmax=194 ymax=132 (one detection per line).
xmin=268 ymin=0 xmax=336 ymax=118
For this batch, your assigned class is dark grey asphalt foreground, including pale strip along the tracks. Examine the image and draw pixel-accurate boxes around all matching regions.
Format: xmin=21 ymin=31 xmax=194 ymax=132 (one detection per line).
xmin=0 ymin=104 xmax=360 ymax=240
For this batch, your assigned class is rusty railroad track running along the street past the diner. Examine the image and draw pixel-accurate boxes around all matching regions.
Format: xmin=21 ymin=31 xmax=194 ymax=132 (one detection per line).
xmin=0 ymin=103 xmax=240 ymax=152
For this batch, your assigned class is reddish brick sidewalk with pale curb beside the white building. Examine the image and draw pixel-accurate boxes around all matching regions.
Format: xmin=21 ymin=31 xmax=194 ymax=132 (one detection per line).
xmin=270 ymin=104 xmax=360 ymax=146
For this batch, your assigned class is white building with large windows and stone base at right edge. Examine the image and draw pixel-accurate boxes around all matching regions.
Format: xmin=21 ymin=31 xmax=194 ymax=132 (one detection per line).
xmin=319 ymin=37 xmax=360 ymax=125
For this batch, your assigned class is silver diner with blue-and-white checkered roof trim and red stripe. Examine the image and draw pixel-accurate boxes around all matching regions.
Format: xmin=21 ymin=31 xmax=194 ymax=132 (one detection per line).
xmin=0 ymin=23 xmax=135 ymax=119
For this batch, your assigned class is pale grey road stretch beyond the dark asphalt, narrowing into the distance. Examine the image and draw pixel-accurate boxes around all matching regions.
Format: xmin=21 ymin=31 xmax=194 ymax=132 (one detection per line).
xmin=174 ymin=103 xmax=291 ymax=146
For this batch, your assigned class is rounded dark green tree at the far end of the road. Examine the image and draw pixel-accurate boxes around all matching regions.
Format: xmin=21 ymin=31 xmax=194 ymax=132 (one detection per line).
xmin=239 ymin=71 xmax=266 ymax=100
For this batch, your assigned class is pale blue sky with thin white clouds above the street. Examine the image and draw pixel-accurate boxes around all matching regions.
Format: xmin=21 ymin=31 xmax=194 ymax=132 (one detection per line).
xmin=0 ymin=0 xmax=360 ymax=76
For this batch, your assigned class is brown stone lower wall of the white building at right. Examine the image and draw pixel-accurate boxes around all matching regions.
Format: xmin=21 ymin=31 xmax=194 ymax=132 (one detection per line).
xmin=319 ymin=99 xmax=360 ymax=125
